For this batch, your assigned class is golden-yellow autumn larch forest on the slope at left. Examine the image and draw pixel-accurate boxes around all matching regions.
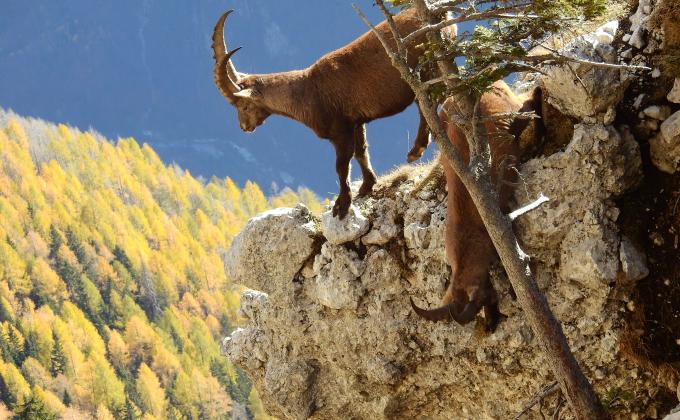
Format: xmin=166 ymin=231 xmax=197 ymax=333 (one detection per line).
xmin=0 ymin=110 xmax=322 ymax=420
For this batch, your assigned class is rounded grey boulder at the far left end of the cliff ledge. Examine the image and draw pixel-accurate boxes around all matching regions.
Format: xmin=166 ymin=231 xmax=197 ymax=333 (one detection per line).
xmin=223 ymin=205 xmax=319 ymax=293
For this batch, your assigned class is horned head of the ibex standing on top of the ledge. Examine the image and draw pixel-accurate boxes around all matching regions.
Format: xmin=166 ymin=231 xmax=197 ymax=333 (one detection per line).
xmin=212 ymin=10 xmax=271 ymax=133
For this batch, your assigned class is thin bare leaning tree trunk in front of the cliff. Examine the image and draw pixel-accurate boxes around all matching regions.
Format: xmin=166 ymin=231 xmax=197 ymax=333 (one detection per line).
xmin=354 ymin=0 xmax=607 ymax=419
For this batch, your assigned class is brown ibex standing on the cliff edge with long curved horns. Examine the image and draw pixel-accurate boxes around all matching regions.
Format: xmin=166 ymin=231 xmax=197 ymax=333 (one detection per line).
xmin=212 ymin=10 xmax=436 ymax=219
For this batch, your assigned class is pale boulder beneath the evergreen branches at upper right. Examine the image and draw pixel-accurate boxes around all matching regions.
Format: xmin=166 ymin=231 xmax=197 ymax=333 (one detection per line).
xmin=541 ymin=37 xmax=631 ymax=121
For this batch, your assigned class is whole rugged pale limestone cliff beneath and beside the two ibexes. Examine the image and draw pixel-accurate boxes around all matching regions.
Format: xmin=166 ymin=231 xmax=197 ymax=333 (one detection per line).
xmin=224 ymin=0 xmax=680 ymax=419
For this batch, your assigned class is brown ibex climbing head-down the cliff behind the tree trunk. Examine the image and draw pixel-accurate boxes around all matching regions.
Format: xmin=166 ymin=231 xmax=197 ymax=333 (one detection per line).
xmin=411 ymin=81 xmax=541 ymax=331
